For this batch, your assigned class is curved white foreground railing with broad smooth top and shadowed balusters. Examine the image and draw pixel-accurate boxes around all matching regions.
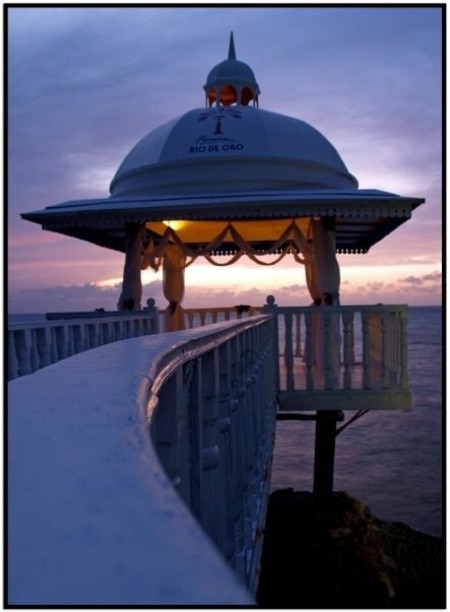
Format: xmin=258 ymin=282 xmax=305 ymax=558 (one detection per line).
xmin=8 ymin=316 xmax=277 ymax=607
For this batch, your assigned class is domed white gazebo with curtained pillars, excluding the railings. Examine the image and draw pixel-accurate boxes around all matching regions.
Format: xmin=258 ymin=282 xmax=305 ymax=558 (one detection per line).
xmin=22 ymin=34 xmax=424 ymax=330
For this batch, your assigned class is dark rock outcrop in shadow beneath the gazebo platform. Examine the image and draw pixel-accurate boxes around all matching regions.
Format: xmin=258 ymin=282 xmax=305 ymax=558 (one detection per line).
xmin=257 ymin=489 xmax=445 ymax=609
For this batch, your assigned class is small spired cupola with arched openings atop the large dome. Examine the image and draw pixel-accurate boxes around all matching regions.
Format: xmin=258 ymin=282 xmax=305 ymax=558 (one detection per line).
xmin=203 ymin=32 xmax=260 ymax=106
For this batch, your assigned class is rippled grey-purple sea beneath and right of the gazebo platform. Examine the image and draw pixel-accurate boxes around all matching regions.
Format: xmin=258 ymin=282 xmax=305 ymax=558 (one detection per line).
xmin=271 ymin=307 xmax=443 ymax=536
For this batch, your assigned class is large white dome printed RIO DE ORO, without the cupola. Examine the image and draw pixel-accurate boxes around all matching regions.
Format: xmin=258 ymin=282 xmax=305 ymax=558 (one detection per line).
xmin=111 ymin=105 xmax=358 ymax=196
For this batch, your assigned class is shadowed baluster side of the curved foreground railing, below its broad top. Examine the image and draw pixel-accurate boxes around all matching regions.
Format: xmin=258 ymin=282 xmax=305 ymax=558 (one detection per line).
xmin=149 ymin=316 xmax=277 ymax=593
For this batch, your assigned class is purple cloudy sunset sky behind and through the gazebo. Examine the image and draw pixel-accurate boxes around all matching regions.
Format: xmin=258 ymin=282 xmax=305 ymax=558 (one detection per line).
xmin=6 ymin=5 xmax=442 ymax=312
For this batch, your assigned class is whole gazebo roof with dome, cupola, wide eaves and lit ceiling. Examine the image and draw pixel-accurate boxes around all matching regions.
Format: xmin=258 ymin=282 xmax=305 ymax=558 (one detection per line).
xmin=22 ymin=33 xmax=424 ymax=254
